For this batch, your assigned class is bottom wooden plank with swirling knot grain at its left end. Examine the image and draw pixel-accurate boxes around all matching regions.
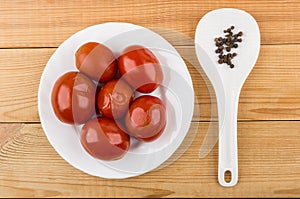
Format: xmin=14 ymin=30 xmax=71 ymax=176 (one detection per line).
xmin=0 ymin=121 xmax=300 ymax=197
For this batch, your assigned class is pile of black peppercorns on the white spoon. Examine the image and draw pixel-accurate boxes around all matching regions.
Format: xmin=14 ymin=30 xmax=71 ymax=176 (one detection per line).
xmin=215 ymin=26 xmax=243 ymax=68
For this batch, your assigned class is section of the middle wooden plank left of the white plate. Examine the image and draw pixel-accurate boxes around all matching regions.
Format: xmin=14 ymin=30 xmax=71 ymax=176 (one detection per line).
xmin=0 ymin=49 xmax=54 ymax=121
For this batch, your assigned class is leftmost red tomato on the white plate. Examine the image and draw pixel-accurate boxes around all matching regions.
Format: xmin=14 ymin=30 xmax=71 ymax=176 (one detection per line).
xmin=51 ymin=72 xmax=96 ymax=124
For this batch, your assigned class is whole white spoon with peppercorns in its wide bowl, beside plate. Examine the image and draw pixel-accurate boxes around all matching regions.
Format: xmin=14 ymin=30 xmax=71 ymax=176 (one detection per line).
xmin=195 ymin=8 xmax=260 ymax=186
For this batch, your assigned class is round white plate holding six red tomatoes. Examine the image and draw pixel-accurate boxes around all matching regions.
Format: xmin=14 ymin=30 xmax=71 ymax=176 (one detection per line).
xmin=38 ymin=23 xmax=194 ymax=178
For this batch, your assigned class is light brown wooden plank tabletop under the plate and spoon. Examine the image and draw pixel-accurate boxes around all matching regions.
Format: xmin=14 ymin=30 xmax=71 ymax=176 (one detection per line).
xmin=0 ymin=0 xmax=300 ymax=197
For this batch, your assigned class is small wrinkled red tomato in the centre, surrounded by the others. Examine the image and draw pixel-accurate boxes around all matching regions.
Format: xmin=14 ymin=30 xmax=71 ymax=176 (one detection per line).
xmin=97 ymin=79 xmax=134 ymax=119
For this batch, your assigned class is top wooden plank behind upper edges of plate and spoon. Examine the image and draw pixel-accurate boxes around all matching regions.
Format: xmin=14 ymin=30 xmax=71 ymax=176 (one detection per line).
xmin=0 ymin=0 xmax=300 ymax=48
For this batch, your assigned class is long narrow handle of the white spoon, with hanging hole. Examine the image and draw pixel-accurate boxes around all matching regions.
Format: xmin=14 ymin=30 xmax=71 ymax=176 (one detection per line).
xmin=218 ymin=89 xmax=240 ymax=187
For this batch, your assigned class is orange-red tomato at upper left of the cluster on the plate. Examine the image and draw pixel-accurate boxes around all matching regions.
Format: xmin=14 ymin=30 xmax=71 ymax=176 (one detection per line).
xmin=75 ymin=42 xmax=117 ymax=82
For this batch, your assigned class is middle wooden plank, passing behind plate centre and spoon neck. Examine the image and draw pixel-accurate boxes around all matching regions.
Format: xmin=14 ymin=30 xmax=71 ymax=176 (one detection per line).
xmin=0 ymin=45 xmax=300 ymax=122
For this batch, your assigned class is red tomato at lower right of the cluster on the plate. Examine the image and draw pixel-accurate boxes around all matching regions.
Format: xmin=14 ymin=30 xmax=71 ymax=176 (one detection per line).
xmin=125 ymin=95 xmax=166 ymax=142
